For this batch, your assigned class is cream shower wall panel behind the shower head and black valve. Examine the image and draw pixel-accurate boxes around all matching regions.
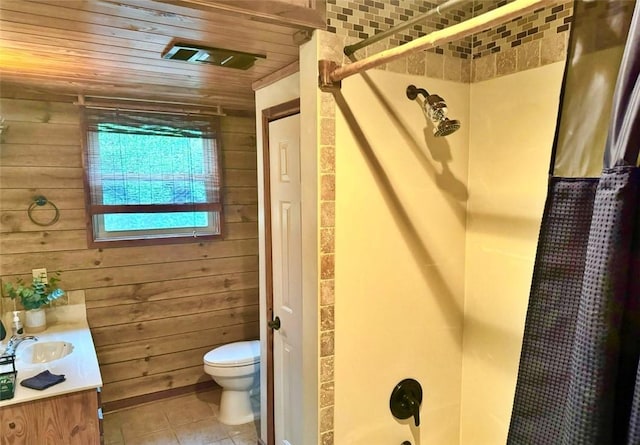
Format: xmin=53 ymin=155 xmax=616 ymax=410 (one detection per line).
xmin=334 ymin=70 xmax=469 ymax=445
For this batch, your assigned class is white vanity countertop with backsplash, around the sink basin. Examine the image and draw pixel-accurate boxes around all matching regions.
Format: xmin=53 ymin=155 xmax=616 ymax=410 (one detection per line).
xmin=0 ymin=304 xmax=102 ymax=408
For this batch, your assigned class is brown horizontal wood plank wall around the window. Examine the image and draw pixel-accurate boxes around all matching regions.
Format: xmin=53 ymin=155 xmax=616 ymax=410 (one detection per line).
xmin=0 ymin=97 xmax=259 ymax=404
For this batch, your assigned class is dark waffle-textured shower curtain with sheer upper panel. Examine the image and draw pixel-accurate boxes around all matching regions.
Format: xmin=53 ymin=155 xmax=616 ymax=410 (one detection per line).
xmin=507 ymin=1 xmax=640 ymax=445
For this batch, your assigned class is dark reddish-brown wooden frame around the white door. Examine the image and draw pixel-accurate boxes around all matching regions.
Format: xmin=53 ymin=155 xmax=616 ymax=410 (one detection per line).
xmin=262 ymin=98 xmax=300 ymax=445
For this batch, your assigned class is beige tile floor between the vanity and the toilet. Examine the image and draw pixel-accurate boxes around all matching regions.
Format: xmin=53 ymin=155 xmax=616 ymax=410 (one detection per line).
xmin=103 ymin=390 xmax=260 ymax=445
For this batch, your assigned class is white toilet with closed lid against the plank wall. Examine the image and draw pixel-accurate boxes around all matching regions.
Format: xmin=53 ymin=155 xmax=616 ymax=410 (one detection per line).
xmin=204 ymin=340 xmax=260 ymax=425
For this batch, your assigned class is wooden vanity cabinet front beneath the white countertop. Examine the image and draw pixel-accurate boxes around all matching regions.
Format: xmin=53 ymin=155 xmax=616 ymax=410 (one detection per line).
xmin=0 ymin=389 xmax=101 ymax=445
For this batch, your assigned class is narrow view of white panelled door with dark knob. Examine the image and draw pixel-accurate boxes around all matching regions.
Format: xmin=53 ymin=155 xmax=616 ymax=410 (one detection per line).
xmin=269 ymin=114 xmax=303 ymax=445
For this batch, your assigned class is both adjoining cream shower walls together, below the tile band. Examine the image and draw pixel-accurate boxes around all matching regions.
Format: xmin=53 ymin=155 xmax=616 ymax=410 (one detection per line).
xmin=334 ymin=63 xmax=563 ymax=445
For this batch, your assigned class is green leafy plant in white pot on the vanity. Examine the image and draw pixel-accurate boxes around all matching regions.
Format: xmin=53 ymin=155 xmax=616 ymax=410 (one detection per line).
xmin=4 ymin=272 xmax=64 ymax=332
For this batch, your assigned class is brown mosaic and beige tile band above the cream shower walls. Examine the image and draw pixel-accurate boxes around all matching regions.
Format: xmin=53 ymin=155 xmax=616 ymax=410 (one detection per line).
xmin=327 ymin=0 xmax=572 ymax=82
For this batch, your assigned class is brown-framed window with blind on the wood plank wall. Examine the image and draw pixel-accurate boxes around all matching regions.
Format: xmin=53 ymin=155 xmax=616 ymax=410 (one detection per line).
xmin=84 ymin=108 xmax=222 ymax=247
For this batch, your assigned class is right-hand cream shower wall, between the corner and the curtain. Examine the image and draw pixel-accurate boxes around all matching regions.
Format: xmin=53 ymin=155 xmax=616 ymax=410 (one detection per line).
xmin=460 ymin=63 xmax=564 ymax=445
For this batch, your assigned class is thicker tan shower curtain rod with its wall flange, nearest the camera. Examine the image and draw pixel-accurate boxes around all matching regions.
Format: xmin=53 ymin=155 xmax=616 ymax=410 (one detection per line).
xmin=319 ymin=0 xmax=554 ymax=90
